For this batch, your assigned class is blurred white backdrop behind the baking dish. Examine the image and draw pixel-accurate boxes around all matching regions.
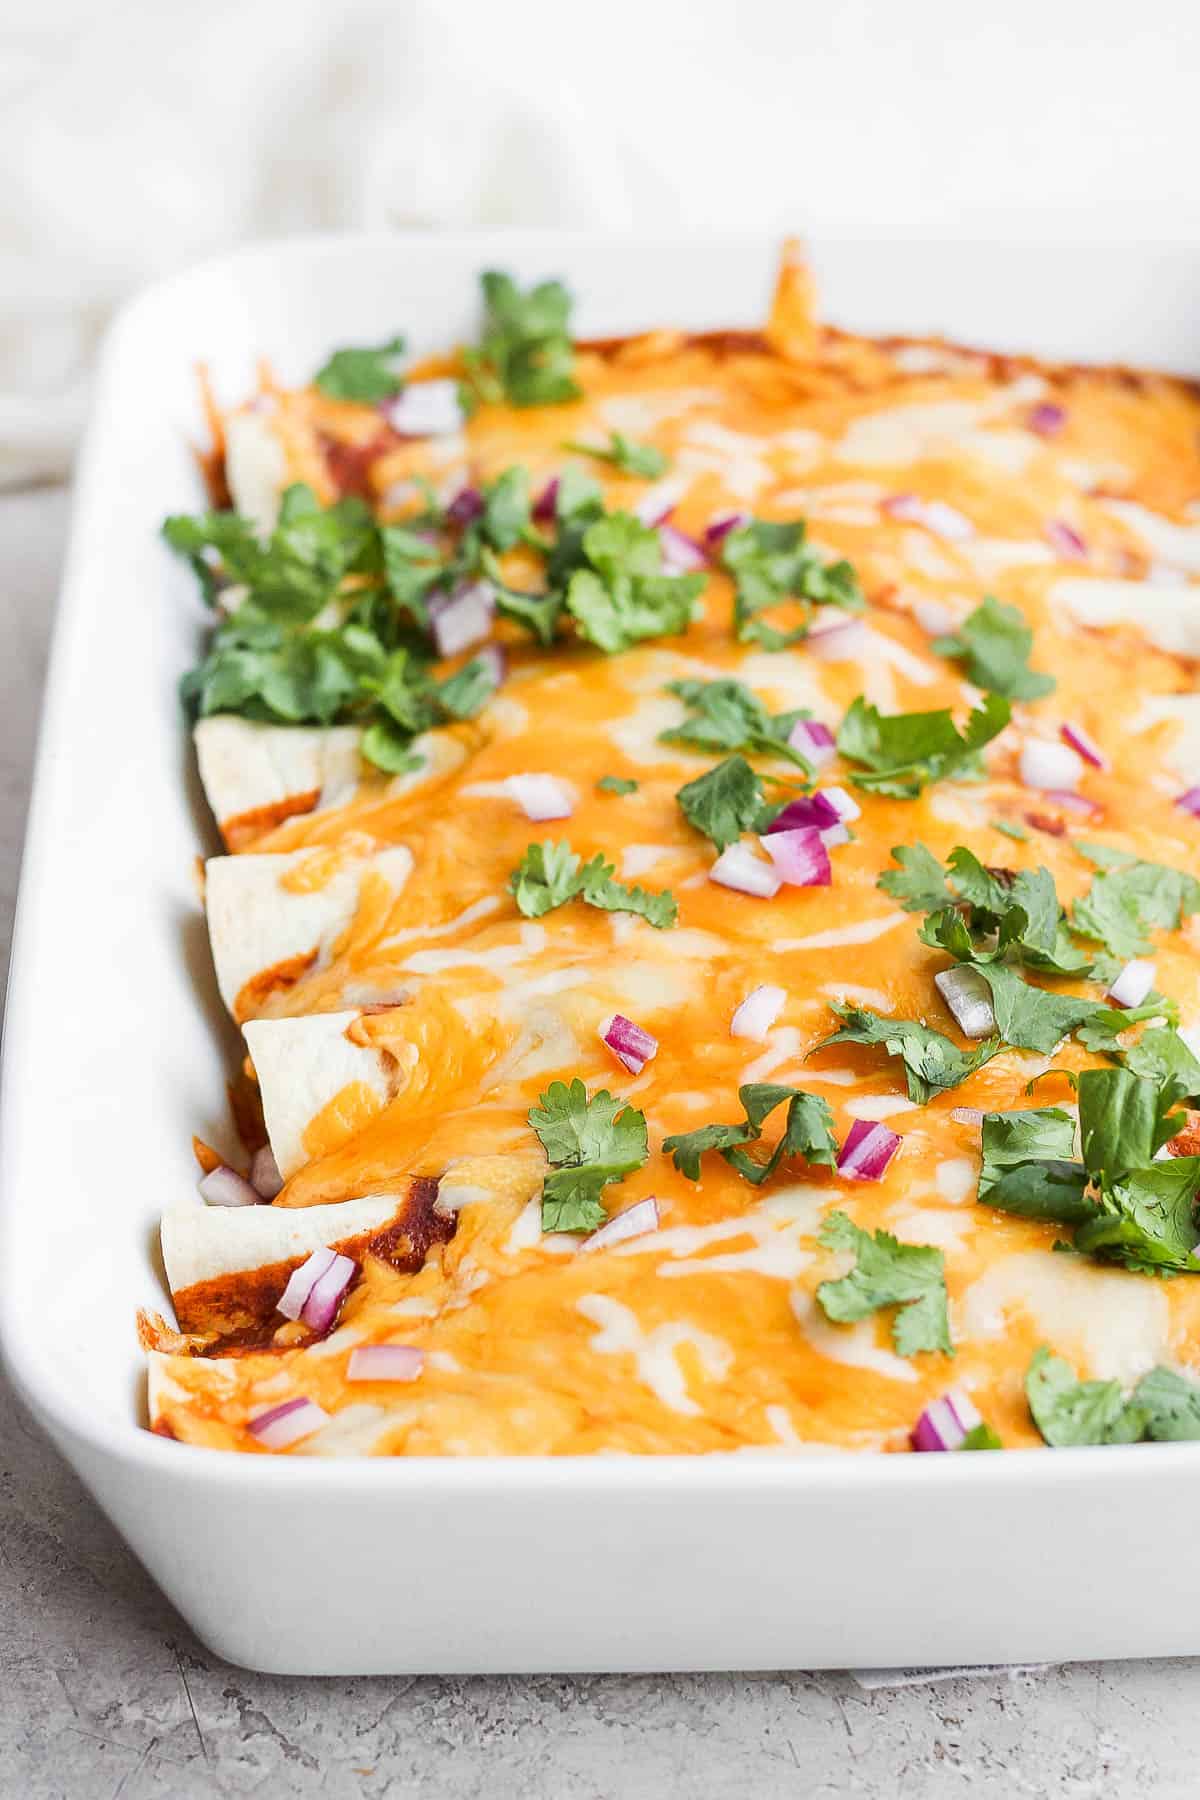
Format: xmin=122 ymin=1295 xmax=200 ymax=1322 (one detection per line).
xmin=0 ymin=0 xmax=1200 ymax=484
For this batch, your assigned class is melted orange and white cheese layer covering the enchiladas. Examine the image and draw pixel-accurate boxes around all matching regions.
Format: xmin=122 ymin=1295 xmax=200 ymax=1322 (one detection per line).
xmin=151 ymin=253 xmax=1200 ymax=1454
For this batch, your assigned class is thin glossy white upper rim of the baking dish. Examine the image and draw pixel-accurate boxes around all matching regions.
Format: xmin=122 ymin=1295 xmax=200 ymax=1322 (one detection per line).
xmin=0 ymin=229 xmax=1200 ymax=1498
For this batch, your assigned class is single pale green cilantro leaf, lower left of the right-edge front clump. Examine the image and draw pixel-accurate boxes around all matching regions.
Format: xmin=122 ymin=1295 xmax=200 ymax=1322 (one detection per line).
xmin=817 ymin=1213 xmax=954 ymax=1355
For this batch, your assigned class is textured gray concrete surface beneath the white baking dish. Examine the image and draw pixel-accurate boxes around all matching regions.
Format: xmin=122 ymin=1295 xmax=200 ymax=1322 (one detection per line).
xmin=0 ymin=491 xmax=1200 ymax=1800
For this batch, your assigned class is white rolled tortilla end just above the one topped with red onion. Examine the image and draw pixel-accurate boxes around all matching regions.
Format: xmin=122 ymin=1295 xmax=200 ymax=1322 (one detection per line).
xmin=245 ymin=1012 xmax=399 ymax=1181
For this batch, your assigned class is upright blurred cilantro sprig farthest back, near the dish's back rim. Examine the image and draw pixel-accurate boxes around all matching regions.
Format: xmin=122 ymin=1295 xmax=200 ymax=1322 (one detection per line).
xmin=462 ymin=270 xmax=579 ymax=407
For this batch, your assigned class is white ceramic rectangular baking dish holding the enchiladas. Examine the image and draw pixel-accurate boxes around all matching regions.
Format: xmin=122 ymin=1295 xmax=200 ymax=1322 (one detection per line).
xmin=0 ymin=234 xmax=1200 ymax=1674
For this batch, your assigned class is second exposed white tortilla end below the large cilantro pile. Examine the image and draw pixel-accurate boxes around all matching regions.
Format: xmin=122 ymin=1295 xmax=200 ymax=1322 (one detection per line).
xmin=205 ymin=844 xmax=412 ymax=1021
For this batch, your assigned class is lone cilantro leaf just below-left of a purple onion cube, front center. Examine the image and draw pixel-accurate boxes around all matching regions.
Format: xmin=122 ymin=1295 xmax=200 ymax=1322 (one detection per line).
xmin=529 ymin=1076 xmax=648 ymax=1231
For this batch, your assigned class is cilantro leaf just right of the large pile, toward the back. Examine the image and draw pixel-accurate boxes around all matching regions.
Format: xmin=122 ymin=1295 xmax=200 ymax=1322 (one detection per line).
xmin=721 ymin=518 xmax=864 ymax=650
